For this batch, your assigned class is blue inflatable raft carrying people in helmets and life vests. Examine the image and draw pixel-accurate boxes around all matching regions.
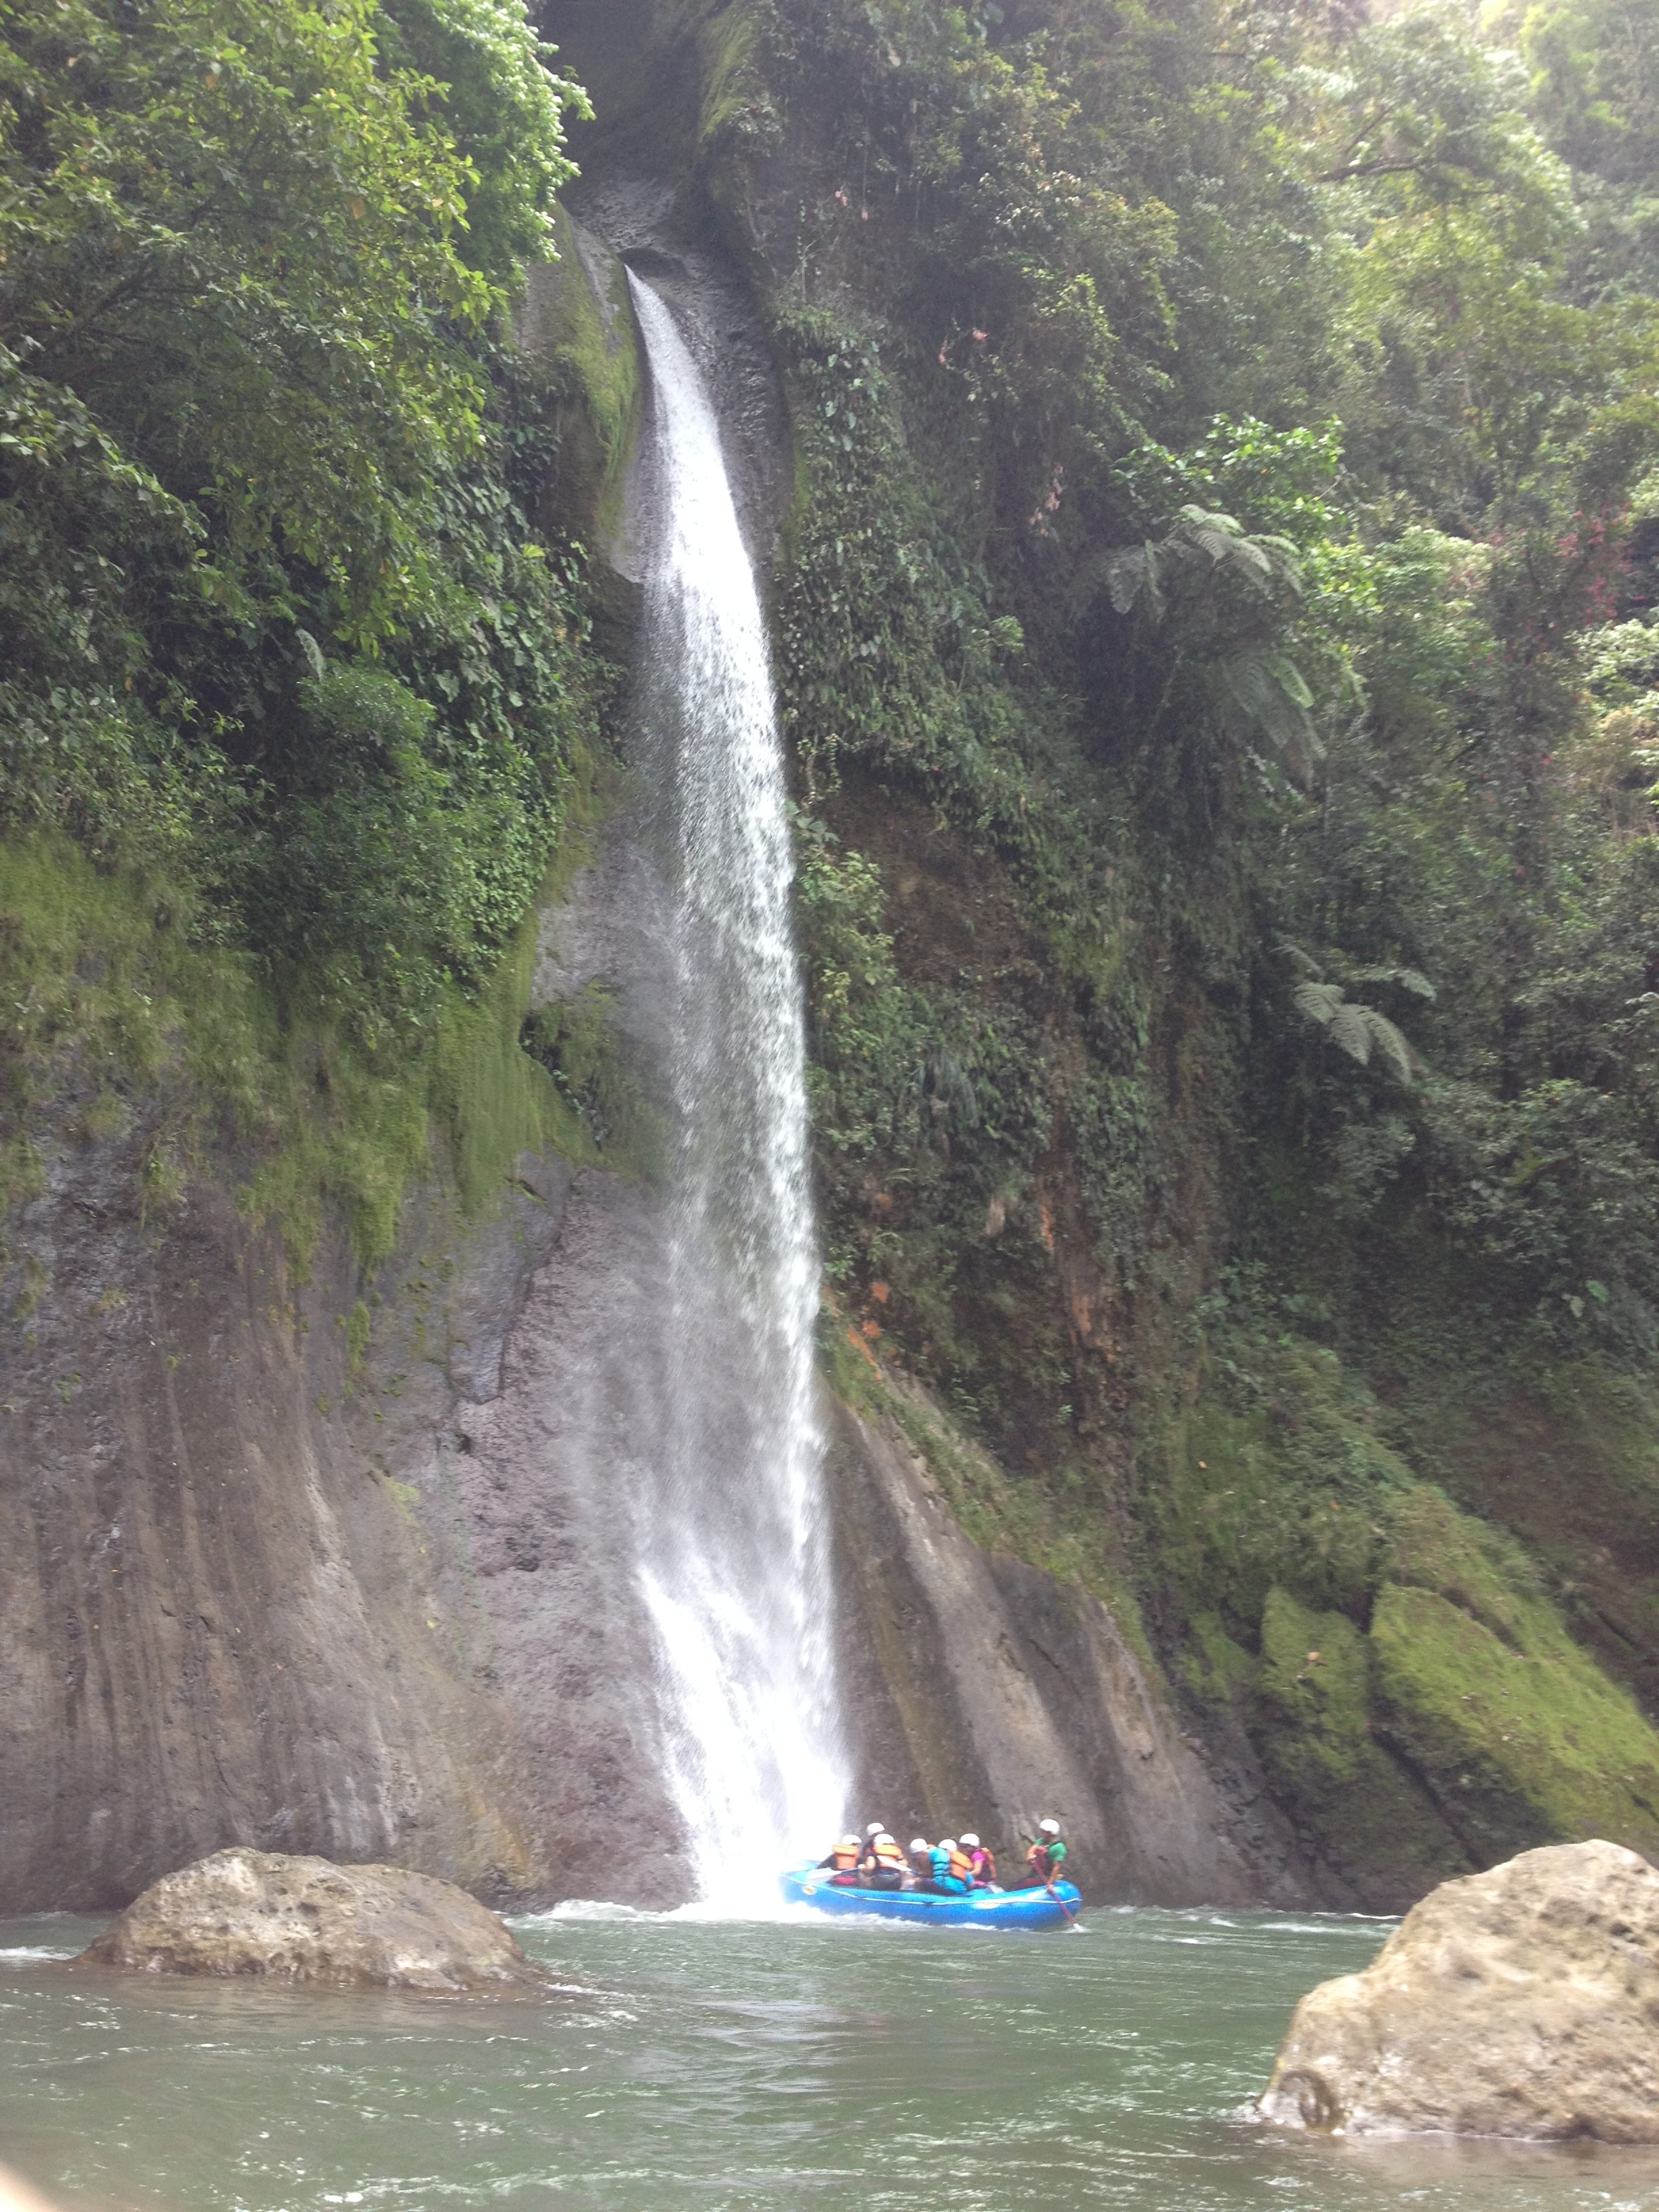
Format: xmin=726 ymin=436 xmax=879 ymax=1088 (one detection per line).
xmin=781 ymin=1818 xmax=1082 ymax=1929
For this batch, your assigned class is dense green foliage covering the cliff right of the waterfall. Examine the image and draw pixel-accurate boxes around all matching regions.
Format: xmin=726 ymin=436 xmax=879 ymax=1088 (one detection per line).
xmin=708 ymin=0 xmax=1659 ymax=1358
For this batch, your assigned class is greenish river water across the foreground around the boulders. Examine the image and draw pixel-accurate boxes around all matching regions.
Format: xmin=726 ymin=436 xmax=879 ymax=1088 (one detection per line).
xmin=0 ymin=1909 xmax=1659 ymax=2212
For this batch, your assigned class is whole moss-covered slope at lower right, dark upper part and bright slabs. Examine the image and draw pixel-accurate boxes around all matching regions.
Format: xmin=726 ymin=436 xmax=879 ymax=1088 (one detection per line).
xmin=1148 ymin=1332 xmax=1659 ymax=1904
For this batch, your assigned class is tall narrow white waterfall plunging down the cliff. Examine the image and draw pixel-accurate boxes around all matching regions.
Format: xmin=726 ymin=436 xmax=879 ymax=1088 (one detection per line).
xmin=628 ymin=274 xmax=847 ymax=1904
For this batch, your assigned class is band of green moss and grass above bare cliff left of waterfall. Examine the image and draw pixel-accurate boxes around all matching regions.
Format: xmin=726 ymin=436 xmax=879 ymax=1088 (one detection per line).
xmin=0 ymin=805 xmax=597 ymax=1274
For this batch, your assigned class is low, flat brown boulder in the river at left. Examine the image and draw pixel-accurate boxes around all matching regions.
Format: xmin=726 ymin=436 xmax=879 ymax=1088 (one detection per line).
xmin=75 ymin=1849 xmax=548 ymax=1991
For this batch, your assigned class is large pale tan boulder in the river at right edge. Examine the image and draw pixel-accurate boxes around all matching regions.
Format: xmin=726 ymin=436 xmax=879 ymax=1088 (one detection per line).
xmin=1261 ymin=1843 xmax=1659 ymax=2144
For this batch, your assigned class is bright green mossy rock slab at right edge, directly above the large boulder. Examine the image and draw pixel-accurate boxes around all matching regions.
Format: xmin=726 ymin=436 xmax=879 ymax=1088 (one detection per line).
xmin=1372 ymin=1584 xmax=1659 ymax=1865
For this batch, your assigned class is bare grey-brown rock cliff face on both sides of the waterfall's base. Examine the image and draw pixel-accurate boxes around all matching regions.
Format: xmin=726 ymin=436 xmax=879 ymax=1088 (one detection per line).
xmin=0 ymin=1115 xmax=1307 ymax=1911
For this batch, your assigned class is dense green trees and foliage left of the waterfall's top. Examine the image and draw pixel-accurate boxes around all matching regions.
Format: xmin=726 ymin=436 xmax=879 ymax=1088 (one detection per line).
xmin=0 ymin=0 xmax=595 ymax=1246
